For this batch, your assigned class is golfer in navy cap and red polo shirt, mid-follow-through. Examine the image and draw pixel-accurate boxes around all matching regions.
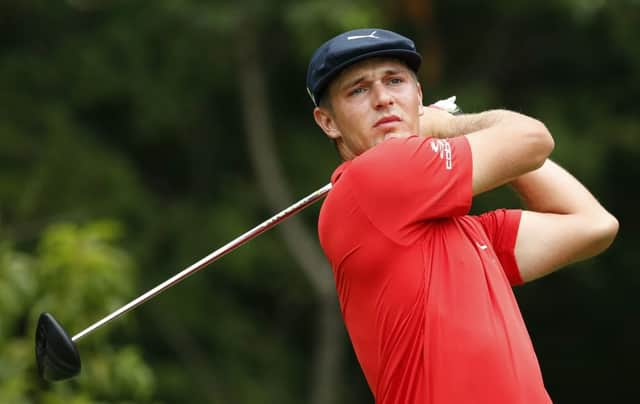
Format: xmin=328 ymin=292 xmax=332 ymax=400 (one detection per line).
xmin=307 ymin=29 xmax=618 ymax=404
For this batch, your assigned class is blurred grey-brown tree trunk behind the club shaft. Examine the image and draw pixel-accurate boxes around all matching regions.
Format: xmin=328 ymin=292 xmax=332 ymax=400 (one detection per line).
xmin=235 ymin=22 xmax=345 ymax=404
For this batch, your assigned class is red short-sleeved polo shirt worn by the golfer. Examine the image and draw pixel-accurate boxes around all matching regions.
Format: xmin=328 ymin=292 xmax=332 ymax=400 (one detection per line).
xmin=318 ymin=136 xmax=551 ymax=404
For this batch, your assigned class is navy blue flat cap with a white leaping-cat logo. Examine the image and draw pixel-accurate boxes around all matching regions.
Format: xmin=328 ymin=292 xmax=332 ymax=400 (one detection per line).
xmin=307 ymin=28 xmax=422 ymax=106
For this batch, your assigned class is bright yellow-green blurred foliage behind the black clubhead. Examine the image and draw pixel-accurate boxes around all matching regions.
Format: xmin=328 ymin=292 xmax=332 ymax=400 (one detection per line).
xmin=0 ymin=220 xmax=156 ymax=404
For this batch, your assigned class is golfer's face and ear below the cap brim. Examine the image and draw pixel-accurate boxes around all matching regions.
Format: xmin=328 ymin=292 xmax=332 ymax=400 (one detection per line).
xmin=314 ymin=58 xmax=422 ymax=160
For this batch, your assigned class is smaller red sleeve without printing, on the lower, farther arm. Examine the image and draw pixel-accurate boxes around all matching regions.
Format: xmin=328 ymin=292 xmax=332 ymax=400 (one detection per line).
xmin=478 ymin=209 xmax=522 ymax=285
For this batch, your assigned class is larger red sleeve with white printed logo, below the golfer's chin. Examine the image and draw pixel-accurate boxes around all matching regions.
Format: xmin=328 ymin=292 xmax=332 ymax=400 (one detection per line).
xmin=350 ymin=136 xmax=472 ymax=244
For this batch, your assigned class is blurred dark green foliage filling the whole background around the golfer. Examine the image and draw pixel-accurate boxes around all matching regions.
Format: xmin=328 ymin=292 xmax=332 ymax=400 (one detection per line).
xmin=0 ymin=0 xmax=640 ymax=404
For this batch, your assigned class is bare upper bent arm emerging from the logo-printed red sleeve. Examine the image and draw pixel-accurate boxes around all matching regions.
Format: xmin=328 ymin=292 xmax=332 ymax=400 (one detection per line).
xmin=420 ymin=107 xmax=554 ymax=195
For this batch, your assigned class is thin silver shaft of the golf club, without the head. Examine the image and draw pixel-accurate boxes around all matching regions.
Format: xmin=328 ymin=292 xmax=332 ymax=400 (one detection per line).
xmin=71 ymin=184 xmax=331 ymax=342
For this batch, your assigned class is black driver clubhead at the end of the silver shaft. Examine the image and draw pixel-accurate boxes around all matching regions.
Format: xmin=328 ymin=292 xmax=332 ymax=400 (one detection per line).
xmin=36 ymin=313 xmax=81 ymax=382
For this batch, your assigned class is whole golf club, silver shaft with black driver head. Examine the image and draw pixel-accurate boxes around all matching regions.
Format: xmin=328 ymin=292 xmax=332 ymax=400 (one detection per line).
xmin=36 ymin=184 xmax=331 ymax=381
